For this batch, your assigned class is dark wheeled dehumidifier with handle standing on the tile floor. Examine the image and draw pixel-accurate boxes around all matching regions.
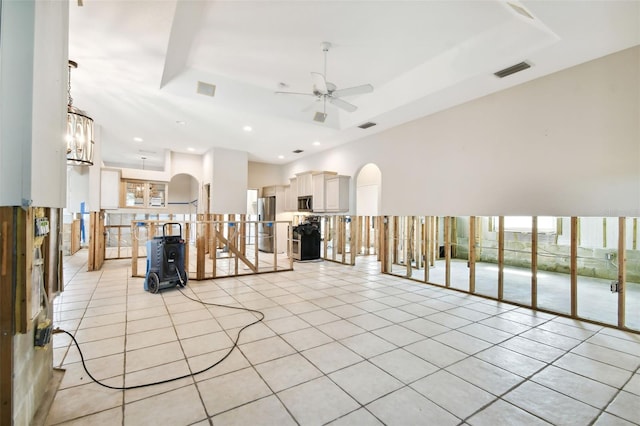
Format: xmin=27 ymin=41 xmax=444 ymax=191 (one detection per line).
xmin=144 ymin=223 xmax=188 ymax=293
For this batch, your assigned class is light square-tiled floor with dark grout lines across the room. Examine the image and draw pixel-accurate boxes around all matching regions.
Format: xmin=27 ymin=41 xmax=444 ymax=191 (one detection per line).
xmin=46 ymin=252 xmax=640 ymax=426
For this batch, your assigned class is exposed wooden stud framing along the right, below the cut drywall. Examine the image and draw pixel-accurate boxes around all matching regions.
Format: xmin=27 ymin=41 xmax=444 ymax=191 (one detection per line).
xmin=380 ymin=216 xmax=640 ymax=331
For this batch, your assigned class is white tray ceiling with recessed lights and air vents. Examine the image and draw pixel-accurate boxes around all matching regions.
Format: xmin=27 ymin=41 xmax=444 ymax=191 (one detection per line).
xmin=69 ymin=0 xmax=640 ymax=168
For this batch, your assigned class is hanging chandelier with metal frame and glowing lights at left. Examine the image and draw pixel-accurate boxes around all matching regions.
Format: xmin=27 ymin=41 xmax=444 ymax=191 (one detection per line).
xmin=66 ymin=60 xmax=94 ymax=166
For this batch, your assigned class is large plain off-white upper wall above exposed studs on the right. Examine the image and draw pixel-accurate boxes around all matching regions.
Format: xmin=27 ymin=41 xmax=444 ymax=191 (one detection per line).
xmin=284 ymin=47 xmax=640 ymax=216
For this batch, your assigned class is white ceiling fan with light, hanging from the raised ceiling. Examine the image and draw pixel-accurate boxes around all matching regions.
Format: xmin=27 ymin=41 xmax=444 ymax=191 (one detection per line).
xmin=276 ymin=41 xmax=373 ymax=121
